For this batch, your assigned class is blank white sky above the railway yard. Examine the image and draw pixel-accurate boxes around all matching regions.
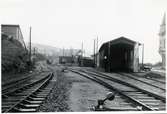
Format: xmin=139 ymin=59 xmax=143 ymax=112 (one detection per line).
xmin=0 ymin=0 xmax=167 ymax=63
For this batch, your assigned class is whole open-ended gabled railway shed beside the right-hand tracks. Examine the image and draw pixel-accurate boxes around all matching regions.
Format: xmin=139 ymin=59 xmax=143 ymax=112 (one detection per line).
xmin=99 ymin=37 xmax=141 ymax=72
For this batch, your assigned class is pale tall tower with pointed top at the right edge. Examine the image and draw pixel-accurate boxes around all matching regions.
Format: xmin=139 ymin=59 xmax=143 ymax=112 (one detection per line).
xmin=159 ymin=13 xmax=166 ymax=69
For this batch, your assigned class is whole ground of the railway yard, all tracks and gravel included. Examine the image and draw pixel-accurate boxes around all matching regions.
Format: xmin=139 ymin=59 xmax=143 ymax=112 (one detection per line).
xmin=2 ymin=64 xmax=166 ymax=113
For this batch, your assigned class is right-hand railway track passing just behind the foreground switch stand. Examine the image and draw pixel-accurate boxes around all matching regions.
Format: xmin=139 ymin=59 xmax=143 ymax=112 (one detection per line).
xmin=70 ymin=69 xmax=165 ymax=111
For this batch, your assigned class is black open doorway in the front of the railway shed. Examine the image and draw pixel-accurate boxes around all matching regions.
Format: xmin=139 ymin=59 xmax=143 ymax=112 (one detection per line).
xmin=109 ymin=43 xmax=134 ymax=71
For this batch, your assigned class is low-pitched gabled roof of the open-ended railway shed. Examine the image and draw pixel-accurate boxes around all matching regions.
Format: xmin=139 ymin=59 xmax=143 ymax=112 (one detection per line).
xmin=99 ymin=36 xmax=140 ymax=51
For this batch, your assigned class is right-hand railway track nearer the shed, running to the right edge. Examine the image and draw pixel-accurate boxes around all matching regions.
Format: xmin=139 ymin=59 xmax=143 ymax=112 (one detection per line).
xmin=84 ymin=69 xmax=166 ymax=99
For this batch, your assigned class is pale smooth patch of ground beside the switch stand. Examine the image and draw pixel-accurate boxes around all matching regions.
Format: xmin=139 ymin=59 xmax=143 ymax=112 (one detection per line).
xmin=65 ymin=72 xmax=109 ymax=112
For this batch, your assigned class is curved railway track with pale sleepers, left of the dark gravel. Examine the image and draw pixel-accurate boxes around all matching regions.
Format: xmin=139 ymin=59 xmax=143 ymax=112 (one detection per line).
xmin=2 ymin=73 xmax=53 ymax=113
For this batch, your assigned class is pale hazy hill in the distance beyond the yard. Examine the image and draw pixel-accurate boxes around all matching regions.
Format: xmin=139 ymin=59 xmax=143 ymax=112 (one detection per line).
xmin=27 ymin=43 xmax=79 ymax=56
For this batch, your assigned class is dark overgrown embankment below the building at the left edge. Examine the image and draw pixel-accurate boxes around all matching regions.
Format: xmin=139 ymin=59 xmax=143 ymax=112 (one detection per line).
xmin=1 ymin=35 xmax=27 ymax=72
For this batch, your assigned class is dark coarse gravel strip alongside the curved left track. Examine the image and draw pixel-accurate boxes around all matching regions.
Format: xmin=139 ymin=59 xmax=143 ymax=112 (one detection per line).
xmin=38 ymin=69 xmax=70 ymax=112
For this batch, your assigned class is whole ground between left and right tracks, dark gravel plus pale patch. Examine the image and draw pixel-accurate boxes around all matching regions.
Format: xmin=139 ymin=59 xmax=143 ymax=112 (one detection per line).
xmin=38 ymin=67 xmax=113 ymax=112
